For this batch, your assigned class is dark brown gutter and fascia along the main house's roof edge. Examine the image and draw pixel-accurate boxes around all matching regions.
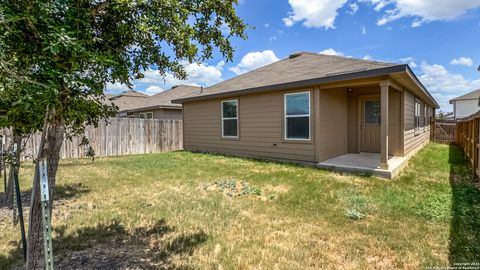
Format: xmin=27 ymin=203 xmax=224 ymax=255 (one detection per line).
xmin=172 ymin=64 xmax=440 ymax=108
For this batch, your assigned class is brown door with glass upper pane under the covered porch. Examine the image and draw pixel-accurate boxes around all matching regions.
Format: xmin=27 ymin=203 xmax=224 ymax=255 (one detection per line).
xmin=360 ymin=96 xmax=381 ymax=153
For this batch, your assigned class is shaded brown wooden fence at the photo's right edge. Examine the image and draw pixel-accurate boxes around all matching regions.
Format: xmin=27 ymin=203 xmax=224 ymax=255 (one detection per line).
xmin=457 ymin=113 xmax=480 ymax=177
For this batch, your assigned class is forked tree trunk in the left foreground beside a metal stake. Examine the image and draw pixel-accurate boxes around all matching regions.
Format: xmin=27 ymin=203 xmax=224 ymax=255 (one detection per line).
xmin=27 ymin=121 xmax=65 ymax=270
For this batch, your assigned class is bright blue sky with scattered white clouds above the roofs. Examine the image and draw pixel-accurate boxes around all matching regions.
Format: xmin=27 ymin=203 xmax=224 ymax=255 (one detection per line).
xmin=108 ymin=0 xmax=480 ymax=111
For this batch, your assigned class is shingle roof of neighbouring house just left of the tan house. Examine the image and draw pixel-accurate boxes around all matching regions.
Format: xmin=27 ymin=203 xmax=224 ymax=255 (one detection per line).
xmin=118 ymin=85 xmax=201 ymax=112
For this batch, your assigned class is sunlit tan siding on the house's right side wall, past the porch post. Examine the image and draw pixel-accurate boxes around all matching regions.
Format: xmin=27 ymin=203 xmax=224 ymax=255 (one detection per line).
xmin=403 ymin=90 xmax=430 ymax=155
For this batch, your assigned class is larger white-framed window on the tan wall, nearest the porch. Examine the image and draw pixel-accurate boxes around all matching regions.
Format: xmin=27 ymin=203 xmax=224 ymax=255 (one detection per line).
xmin=285 ymin=92 xmax=310 ymax=140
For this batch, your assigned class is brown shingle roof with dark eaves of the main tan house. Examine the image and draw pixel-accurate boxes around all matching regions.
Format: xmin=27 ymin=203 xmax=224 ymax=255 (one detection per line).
xmin=174 ymin=52 xmax=438 ymax=107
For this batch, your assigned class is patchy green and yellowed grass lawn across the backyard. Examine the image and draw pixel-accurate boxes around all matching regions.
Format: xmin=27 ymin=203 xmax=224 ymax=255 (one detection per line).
xmin=0 ymin=144 xmax=480 ymax=269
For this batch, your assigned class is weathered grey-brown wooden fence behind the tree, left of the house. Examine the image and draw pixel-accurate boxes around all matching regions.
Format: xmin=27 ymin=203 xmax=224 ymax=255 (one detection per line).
xmin=0 ymin=118 xmax=183 ymax=160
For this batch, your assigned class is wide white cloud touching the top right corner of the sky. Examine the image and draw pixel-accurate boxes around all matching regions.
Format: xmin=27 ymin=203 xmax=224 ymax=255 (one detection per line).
xmin=361 ymin=0 xmax=480 ymax=27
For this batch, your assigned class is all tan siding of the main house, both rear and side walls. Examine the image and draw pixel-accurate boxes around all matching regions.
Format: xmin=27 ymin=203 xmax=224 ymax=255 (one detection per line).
xmin=183 ymin=86 xmax=430 ymax=162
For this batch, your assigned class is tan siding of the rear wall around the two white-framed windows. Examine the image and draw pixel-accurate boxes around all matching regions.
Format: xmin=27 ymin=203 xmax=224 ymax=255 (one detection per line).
xmin=184 ymin=89 xmax=315 ymax=162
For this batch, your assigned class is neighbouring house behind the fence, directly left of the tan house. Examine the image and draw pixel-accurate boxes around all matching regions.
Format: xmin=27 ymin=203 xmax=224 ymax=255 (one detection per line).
xmin=112 ymin=85 xmax=200 ymax=120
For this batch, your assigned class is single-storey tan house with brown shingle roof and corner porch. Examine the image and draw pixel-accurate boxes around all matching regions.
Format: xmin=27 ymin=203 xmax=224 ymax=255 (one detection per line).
xmin=174 ymin=52 xmax=439 ymax=178
